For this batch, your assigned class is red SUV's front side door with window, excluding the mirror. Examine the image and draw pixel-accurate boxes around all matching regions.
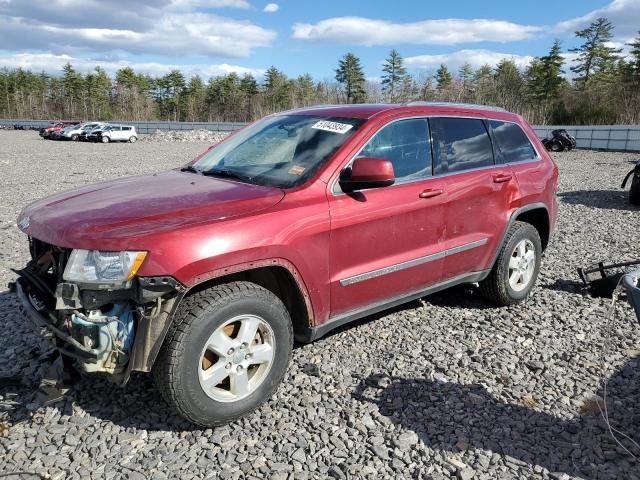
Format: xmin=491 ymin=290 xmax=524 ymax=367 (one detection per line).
xmin=329 ymin=118 xmax=447 ymax=317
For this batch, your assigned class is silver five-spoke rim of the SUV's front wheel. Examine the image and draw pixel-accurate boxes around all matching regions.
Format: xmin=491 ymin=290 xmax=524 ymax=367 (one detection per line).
xmin=198 ymin=315 xmax=276 ymax=402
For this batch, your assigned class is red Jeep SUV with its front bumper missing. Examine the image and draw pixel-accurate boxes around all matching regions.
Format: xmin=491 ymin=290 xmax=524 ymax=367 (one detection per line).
xmin=13 ymin=103 xmax=558 ymax=425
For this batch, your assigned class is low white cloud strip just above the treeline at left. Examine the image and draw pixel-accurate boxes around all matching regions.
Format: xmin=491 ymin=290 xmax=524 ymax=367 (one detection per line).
xmin=0 ymin=53 xmax=265 ymax=79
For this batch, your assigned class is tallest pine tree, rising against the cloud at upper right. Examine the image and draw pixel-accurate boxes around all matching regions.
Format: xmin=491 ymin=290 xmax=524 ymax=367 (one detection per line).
xmin=569 ymin=17 xmax=622 ymax=88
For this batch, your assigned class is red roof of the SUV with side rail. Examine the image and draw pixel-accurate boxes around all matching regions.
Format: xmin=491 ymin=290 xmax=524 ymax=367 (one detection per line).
xmin=282 ymin=102 xmax=519 ymax=119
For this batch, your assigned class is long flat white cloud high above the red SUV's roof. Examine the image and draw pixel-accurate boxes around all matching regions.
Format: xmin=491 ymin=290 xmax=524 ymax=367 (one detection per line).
xmin=293 ymin=17 xmax=543 ymax=46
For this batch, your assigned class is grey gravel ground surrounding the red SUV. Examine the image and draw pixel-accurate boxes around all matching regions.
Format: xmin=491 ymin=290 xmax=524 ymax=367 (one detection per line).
xmin=0 ymin=131 xmax=640 ymax=479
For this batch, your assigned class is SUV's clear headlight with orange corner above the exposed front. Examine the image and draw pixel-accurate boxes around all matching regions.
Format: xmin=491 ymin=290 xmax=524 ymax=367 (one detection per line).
xmin=63 ymin=250 xmax=147 ymax=283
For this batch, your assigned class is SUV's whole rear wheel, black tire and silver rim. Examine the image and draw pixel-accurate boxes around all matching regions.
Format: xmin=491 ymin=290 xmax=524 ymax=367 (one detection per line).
xmin=480 ymin=222 xmax=542 ymax=305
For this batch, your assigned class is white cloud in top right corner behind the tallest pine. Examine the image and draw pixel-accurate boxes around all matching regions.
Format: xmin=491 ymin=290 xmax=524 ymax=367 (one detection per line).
xmin=555 ymin=0 xmax=640 ymax=38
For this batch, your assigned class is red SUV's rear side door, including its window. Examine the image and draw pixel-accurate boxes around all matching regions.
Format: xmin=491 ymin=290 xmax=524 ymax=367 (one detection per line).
xmin=429 ymin=117 xmax=516 ymax=279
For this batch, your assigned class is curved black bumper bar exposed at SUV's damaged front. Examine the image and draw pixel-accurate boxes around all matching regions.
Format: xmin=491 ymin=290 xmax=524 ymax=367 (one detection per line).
xmin=15 ymin=278 xmax=97 ymax=363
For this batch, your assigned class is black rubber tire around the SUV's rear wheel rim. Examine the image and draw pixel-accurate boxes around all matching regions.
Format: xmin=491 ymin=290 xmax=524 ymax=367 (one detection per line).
xmin=480 ymin=221 xmax=542 ymax=306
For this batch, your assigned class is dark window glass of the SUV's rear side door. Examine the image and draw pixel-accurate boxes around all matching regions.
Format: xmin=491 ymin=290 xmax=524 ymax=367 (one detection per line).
xmin=429 ymin=117 xmax=493 ymax=174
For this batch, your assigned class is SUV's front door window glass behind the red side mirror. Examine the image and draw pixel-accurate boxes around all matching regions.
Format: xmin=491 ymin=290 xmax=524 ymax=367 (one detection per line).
xmin=358 ymin=118 xmax=431 ymax=182
